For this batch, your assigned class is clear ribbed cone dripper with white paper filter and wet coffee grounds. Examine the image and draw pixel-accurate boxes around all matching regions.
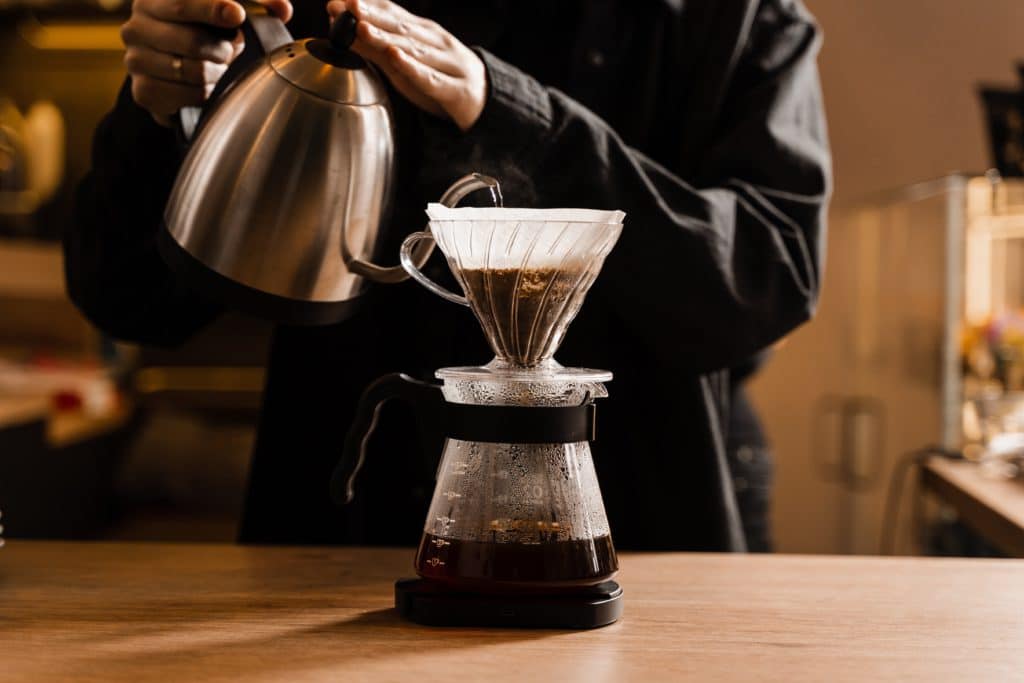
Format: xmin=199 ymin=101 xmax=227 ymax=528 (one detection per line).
xmin=401 ymin=204 xmax=626 ymax=368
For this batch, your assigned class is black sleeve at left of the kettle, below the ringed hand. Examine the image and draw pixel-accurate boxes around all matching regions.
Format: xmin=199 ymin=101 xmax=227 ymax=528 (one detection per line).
xmin=63 ymin=82 xmax=218 ymax=346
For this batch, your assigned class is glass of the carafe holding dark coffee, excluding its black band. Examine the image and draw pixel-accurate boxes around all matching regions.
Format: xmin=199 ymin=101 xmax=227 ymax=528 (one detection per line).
xmin=416 ymin=368 xmax=618 ymax=591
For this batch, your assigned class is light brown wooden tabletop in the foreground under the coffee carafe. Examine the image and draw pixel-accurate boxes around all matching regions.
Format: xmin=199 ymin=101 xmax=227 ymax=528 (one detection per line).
xmin=6 ymin=541 xmax=1024 ymax=683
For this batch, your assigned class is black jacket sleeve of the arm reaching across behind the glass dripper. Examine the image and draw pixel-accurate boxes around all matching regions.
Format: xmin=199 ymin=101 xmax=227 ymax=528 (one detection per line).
xmin=436 ymin=1 xmax=830 ymax=373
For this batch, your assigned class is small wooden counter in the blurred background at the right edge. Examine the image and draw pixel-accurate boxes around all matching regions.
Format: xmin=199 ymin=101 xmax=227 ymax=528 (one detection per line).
xmin=921 ymin=458 xmax=1024 ymax=557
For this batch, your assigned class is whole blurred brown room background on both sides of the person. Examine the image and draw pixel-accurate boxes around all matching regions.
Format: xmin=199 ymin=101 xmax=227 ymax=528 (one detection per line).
xmin=0 ymin=0 xmax=1024 ymax=555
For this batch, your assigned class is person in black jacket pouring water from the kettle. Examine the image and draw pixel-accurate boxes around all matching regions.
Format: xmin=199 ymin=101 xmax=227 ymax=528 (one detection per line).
xmin=65 ymin=0 xmax=830 ymax=551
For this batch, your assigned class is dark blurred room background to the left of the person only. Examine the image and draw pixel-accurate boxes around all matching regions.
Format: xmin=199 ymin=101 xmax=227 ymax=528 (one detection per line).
xmin=0 ymin=0 xmax=269 ymax=541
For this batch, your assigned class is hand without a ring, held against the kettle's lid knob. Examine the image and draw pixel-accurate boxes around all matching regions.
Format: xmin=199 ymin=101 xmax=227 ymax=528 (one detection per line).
xmin=327 ymin=0 xmax=487 ymax=131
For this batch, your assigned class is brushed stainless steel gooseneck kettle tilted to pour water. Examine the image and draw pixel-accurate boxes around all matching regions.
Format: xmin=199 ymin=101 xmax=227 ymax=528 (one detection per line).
xmin=160 ymin=2 xmax=494 ymax=325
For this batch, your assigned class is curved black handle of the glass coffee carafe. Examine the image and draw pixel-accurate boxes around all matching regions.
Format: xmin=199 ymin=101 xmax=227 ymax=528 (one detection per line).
xmin=331 ymin=373 xmax=443 ymax=504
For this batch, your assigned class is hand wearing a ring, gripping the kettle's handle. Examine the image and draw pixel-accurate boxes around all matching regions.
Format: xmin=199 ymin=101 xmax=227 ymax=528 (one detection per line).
xmin=121 ymin=0 xmax=292 ymax=126
